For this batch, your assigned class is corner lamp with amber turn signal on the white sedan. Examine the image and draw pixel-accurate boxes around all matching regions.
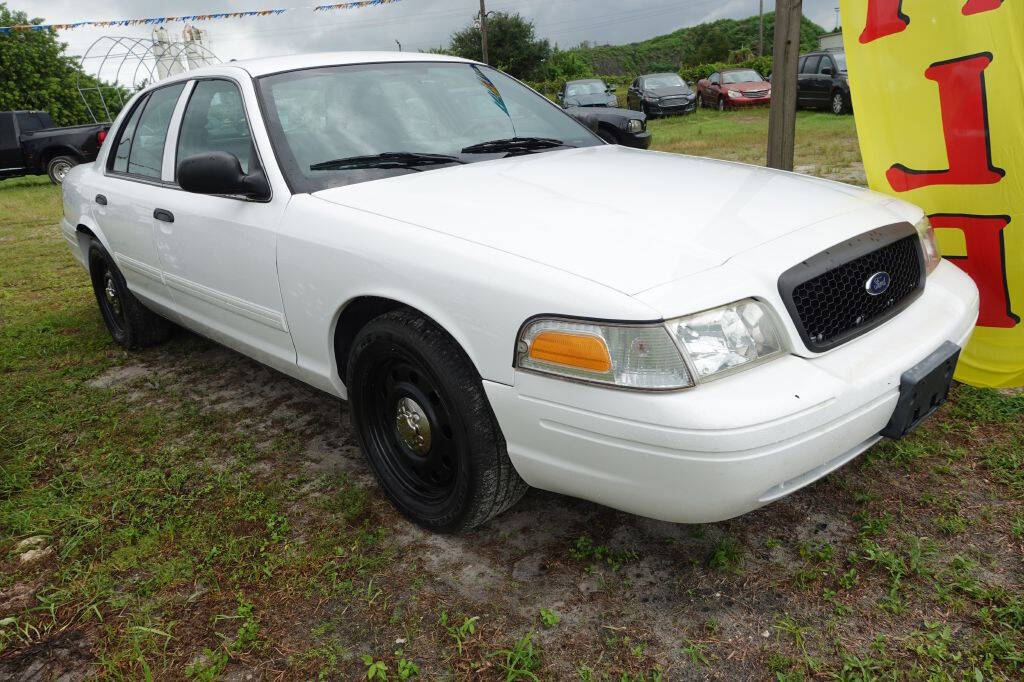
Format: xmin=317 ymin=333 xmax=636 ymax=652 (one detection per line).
xmin=516 ymin=317 xmax=693 ymax=390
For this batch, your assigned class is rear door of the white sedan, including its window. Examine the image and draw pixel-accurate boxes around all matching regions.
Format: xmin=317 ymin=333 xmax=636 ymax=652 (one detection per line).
xmin=98 ymin=83 xmax=184 ymax=314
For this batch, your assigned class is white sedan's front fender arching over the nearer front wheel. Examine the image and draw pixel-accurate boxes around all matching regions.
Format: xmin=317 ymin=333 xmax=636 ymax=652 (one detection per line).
xmin=278 ymin=193 xmax=656 ymax=396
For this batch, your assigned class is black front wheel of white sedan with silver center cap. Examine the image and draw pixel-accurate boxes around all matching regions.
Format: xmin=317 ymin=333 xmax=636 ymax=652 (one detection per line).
xmin=346 ymin=308 xmax=527 ymax=534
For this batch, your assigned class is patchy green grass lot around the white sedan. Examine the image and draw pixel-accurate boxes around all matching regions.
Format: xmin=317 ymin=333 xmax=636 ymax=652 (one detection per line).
xmin=0 ymin=119 xmax=1024 ymax=680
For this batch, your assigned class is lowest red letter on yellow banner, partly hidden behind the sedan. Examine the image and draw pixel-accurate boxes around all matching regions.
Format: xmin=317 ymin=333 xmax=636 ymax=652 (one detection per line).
xmin=928 ymin=213 xmax=1021 ymax=327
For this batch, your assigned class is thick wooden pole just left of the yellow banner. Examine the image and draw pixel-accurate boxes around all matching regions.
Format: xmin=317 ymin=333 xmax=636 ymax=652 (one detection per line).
xmin=768 ymin=0 xmax=803 ymax=171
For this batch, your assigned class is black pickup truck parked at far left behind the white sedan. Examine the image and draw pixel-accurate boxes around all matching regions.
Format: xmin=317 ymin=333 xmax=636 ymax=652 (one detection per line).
xmin=0 ymin=112 xmax=111 ymax=184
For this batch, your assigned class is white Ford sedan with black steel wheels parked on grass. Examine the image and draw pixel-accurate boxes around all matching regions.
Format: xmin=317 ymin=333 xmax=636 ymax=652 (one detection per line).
xmin=60 ymin=53 xmax=978 ymax=532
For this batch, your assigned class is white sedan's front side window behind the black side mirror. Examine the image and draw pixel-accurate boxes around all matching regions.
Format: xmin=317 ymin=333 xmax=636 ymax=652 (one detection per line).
xmin=176 ymin=80 xmax=257 ymax=173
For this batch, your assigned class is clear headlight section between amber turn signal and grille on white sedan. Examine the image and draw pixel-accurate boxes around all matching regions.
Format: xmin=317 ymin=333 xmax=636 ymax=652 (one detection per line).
xmin=666 ymin=298 xmax=785 ymax=380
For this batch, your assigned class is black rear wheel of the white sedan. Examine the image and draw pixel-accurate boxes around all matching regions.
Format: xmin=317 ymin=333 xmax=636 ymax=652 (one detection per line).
xmin=89 ymin=239 xmax=174 ymax=350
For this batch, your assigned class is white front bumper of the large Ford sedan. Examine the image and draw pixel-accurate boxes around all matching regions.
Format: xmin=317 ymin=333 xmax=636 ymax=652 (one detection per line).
xmin=484 ymin=263 xmax=978 ymax=523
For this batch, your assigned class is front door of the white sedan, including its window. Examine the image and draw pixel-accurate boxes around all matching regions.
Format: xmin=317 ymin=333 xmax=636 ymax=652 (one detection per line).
xmin=153 ymin=79 xmax=295 ymax=369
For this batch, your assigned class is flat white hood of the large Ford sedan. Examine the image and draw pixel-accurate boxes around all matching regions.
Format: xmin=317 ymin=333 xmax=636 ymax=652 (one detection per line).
xmin=313 ymin=144 xmax=887 ymax=295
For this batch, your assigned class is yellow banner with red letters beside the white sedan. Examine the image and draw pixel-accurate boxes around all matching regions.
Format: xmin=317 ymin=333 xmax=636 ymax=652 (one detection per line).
xmin=841 ymin=0 xmax=1024 ymax=387
